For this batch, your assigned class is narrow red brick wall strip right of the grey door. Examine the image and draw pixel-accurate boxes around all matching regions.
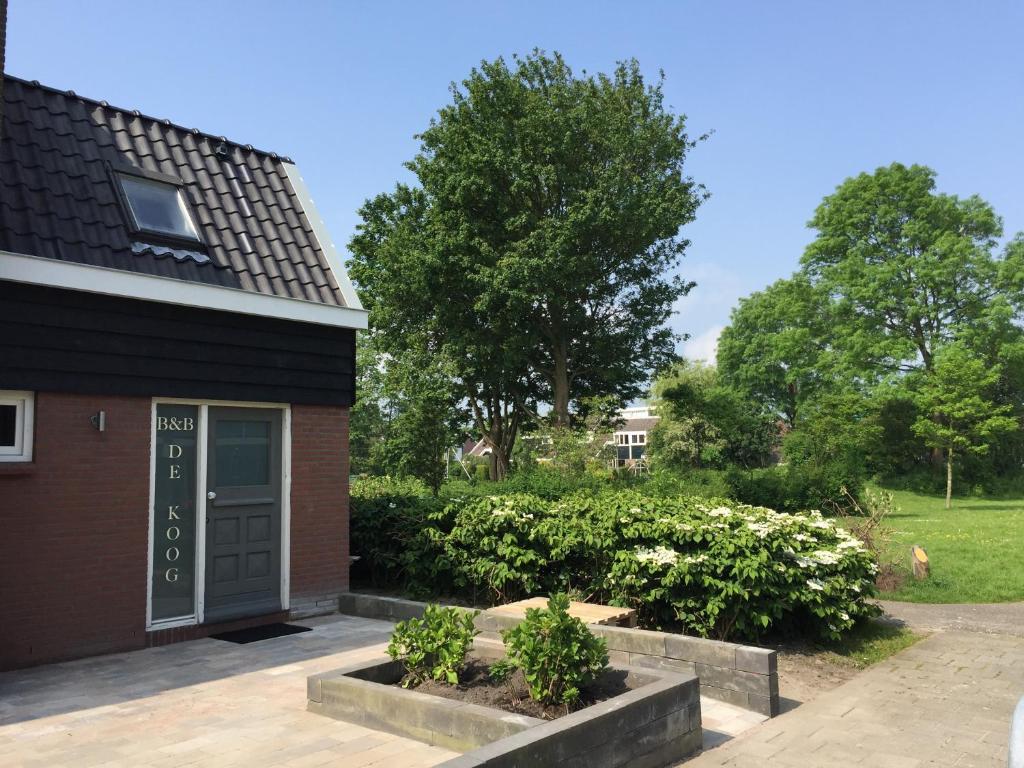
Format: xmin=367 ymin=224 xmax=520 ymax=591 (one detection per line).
xmin=291 ymin=406 xmax=348 ymax=605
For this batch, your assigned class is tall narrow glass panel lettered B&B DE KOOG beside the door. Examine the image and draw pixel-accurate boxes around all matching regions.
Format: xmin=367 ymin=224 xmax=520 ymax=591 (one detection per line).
xmin=151 ymin=404 xmax=199 ymax=622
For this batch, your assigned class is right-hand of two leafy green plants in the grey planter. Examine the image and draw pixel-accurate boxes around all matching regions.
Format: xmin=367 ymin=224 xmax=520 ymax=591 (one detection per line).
xmin=490 ymin=595 xmax=608 ymax=705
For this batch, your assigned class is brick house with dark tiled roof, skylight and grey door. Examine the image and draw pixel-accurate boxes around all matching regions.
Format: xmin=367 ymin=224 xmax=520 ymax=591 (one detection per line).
xmin=0 ymin=14 xmax=367 ymax=669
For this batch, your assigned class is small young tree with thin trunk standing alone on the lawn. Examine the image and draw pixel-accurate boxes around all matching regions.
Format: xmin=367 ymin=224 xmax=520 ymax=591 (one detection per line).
xmin=913 ymin=343 xmax=1019 ymax=509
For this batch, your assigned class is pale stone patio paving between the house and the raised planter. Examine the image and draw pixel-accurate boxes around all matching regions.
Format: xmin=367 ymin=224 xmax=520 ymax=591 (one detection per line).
xmin=0 ymin=615 xmax=764 ymax=768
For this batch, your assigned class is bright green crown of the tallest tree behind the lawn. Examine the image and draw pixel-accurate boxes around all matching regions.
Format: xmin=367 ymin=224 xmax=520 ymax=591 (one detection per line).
xmin=802 ymin=163 xmax=1024 ymax=376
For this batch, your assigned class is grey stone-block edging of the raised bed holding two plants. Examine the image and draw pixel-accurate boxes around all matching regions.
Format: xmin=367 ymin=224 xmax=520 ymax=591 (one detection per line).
xmin=307 ymin=649 xmax=701 ymax=768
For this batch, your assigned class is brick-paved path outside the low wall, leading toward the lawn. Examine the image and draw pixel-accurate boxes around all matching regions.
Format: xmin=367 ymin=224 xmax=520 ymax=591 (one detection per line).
xmin=685 ymin=632 xmax=1024 ymax=768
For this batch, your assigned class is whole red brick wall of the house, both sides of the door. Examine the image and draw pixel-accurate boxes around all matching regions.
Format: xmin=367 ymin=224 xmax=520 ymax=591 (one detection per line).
xmin=0 ymin=392 xmax=348 ymax=669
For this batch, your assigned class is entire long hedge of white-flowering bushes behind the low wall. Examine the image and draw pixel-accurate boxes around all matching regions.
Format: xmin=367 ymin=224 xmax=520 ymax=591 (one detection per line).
xmin=353 ymin=490 xmax=877 ymax=639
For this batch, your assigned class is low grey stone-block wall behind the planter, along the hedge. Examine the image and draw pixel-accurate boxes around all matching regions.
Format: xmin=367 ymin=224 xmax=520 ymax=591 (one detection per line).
xmin=338 ymin=592 xmax=779 ymax=717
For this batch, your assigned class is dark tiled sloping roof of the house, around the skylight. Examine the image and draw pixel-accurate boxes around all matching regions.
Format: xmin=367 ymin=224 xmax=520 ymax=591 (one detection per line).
xmin=0 ymin=76 xmax=357 ymax=306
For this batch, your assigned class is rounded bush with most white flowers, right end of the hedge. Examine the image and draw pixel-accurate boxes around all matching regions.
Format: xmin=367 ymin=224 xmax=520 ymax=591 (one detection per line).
xmin=606 ymin=498 xmax=877 ymax=639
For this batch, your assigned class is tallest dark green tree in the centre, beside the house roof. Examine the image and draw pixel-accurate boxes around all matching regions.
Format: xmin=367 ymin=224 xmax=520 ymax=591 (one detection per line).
xmin=350 ymin=52 xmax=705 ymax=475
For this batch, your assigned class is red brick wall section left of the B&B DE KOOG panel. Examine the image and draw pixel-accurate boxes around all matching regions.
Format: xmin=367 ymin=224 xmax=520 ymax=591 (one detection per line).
xmin=0 ymin=392 xmax=151 ymax=669
